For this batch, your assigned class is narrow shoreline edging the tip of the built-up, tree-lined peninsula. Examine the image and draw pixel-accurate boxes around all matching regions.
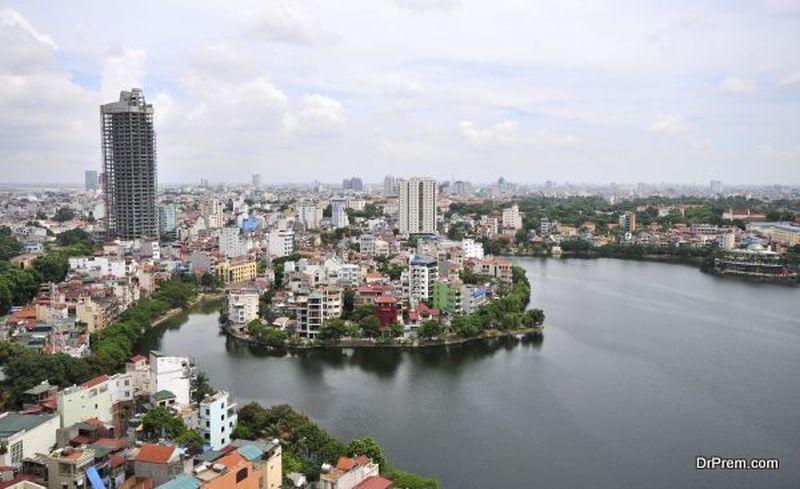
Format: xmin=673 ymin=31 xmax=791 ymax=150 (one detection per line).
xmin=221 ymin=325 xmax=544 ymax=351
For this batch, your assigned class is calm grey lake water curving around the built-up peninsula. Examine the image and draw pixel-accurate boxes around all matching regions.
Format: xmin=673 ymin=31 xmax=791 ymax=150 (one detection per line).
xmin=138 ymin=259 xmax=800 ymax=489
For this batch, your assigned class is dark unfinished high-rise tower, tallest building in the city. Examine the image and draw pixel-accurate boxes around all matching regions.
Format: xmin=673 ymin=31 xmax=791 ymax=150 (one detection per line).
xmin=100 ymin=88 xmax=158 ymax=240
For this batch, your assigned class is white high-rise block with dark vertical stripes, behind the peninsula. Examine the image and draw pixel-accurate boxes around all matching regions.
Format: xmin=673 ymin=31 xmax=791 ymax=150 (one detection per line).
xmin=399 ymin=177 xmax=436 ymax=235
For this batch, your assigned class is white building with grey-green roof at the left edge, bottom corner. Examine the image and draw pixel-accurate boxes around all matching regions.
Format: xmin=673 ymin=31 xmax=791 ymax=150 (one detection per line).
xmin=0 ymin=412 xmax=60 ymax=468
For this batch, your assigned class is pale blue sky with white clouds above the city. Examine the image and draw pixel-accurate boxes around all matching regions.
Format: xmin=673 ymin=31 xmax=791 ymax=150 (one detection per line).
xmin=0 ymin=0 xmax=800 ymax=185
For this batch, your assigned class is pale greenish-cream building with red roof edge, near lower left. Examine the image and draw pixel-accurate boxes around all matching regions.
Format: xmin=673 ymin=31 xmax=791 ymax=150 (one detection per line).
xmin=58 ymin=375 xmax=114 ymax=428
